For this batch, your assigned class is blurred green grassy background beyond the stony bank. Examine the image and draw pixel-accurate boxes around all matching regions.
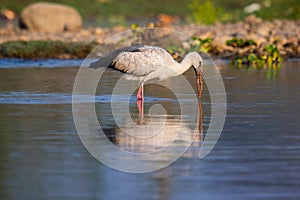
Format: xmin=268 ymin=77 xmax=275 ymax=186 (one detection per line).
xmin=0 ymin=0 xmax=300 ymax=26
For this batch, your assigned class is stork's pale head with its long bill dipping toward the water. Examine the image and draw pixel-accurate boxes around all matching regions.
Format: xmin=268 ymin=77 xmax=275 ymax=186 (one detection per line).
xmin=186 ymin=52 xmax=203 ymax=97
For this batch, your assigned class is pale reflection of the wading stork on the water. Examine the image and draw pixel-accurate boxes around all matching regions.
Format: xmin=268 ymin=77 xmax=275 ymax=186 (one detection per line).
xmin=104 ymin=102 xmax=203 ymax=156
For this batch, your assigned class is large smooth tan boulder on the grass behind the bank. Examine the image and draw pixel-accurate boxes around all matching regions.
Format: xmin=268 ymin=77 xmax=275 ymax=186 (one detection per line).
xmin=20 ymin=2 xmax=82 ymax=32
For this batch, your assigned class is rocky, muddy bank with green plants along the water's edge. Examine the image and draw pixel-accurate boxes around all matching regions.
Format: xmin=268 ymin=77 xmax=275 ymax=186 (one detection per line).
xmin=0 ymin=16 xmax=300 ymax=59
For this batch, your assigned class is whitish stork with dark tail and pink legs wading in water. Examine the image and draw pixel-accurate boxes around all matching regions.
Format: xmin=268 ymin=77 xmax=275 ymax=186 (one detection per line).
xmin=90 ymin=45 xmax=203 ymax=101
